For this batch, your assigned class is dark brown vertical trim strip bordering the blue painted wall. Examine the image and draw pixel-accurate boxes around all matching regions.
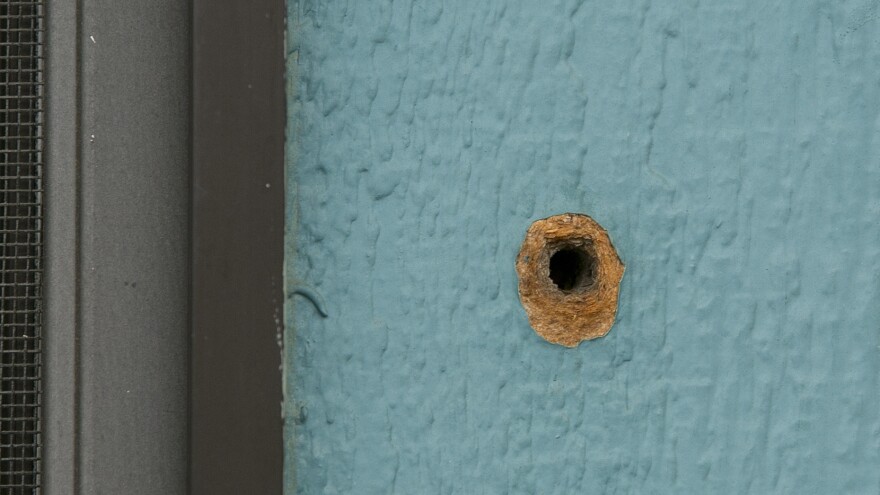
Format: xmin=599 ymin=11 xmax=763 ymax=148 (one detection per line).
xmin=190 ymin=0 xmax=286 ymax=495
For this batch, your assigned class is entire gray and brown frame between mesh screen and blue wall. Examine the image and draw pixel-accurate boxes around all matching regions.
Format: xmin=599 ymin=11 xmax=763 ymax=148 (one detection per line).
xmin=43 ymin=0 xmax=285 ymax=495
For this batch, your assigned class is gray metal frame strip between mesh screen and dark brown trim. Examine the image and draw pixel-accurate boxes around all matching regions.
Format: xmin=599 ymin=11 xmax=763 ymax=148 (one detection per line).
xmin=43 ymin=0 xmax=191 ymax=495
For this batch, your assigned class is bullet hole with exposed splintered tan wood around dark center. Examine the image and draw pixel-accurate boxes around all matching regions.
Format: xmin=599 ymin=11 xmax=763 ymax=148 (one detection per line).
xmin=516 ymin=213 xmax=624 ymax=347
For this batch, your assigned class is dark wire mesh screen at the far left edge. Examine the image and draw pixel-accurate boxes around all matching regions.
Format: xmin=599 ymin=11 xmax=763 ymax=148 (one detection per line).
xmin=0 ymin=0 xmax=44 ymax=494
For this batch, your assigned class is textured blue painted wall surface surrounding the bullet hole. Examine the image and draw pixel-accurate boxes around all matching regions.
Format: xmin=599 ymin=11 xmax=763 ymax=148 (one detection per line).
xmin=285 ymin=0 xmax=880 ymax=494
